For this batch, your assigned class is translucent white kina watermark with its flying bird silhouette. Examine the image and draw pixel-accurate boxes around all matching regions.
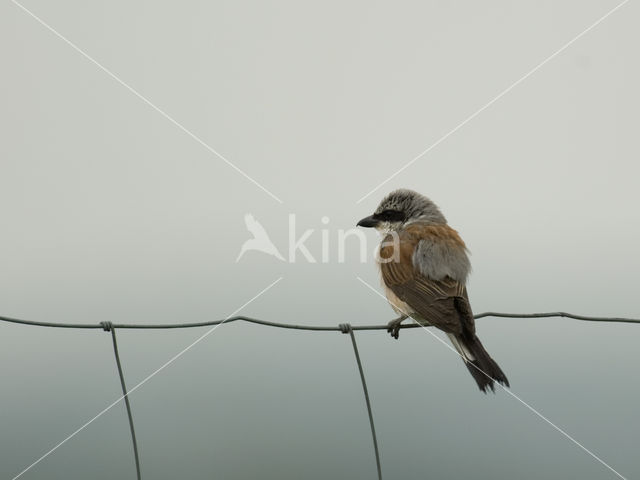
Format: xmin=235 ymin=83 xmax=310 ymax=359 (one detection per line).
xmin=236 ymin=213 xmax=400 ymax=263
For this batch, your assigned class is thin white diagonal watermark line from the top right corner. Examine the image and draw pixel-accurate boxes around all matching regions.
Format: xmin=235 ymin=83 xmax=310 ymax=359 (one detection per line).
xmin=356 ymin=0 xmax=629 ymax=204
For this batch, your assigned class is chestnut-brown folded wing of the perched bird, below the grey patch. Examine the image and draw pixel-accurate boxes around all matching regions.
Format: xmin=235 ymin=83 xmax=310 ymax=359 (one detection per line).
xmin=380 ymin=224 xmax=475 ymax=334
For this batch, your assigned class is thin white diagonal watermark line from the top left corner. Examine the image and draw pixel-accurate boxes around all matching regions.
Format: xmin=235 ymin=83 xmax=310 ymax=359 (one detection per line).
xmin=10 ymin=0 xmax=283 ymax=203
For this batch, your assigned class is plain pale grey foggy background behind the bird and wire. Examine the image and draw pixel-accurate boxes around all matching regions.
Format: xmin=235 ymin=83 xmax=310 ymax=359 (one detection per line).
xmin=0 ymin=0 xmax=640 ymax=480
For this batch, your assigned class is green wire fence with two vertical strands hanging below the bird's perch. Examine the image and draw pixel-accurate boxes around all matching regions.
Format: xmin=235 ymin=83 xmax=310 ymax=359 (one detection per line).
xmin=0 ymin=312 xmax=640 ymax=480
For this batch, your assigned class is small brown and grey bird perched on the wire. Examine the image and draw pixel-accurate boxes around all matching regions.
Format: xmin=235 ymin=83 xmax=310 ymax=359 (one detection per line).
xmin=357 ymin=189 xmax=509 ymax=393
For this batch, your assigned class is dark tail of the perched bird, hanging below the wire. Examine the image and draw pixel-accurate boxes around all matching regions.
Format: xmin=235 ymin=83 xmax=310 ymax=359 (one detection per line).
xmin=447 ymin=333 xmax=509 ymax=393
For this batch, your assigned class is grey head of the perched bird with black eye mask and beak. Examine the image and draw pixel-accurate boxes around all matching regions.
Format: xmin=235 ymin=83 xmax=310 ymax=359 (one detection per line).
xmin=357 ymin=188 xmax=447 ymax=232
